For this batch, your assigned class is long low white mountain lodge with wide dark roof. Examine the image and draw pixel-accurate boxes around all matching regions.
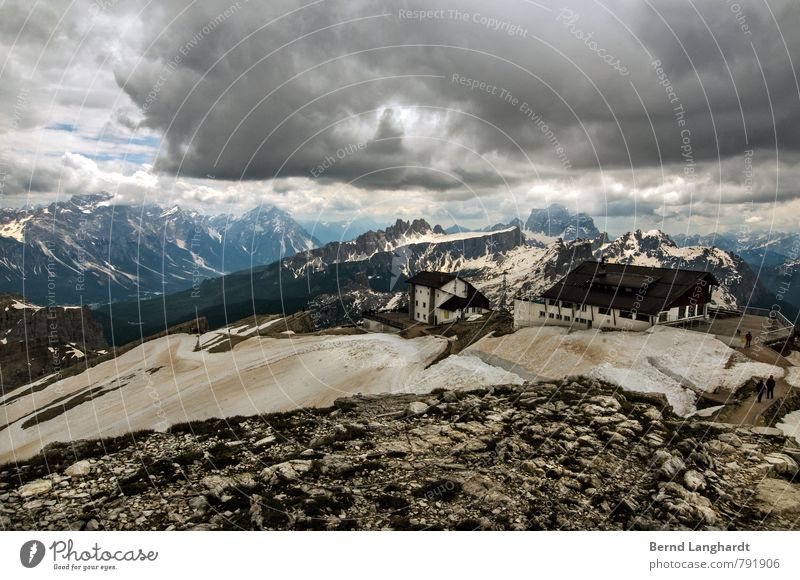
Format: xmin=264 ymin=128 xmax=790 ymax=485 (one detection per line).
xmin=514 ymin=260 xmax=719 ymax=330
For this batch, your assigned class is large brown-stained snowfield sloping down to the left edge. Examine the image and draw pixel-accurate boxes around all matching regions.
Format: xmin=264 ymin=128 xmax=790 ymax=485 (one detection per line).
xmin=0 ymin=327 xmax=522 ymax=464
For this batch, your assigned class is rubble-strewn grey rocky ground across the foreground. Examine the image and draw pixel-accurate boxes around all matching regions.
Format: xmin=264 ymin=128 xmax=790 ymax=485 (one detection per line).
xmin=0 ymin=379 xmax=800 ymax=530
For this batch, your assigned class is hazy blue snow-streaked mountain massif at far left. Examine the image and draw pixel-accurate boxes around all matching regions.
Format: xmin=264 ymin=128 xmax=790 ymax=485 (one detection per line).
xmin=0 ymin=194 xmax=319 ymax=304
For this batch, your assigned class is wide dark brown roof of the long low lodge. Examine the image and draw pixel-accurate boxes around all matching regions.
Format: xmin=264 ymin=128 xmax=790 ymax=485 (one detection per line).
xmin=542 ymin=260 xmax=719 ymax=314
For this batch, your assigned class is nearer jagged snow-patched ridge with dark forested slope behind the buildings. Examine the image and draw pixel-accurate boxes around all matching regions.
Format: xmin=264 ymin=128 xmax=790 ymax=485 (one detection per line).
xmin=96 ymin=214 xmax=769 ymax=344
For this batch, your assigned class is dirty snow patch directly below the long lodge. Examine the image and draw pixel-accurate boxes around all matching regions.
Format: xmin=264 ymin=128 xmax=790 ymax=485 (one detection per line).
xmin=465 ymin=326 xmax=783 ymax=416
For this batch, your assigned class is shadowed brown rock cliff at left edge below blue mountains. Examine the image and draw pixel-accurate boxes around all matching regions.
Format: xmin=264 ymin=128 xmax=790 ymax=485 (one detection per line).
xmin=0 ymin=294 xmax=107 ymax=392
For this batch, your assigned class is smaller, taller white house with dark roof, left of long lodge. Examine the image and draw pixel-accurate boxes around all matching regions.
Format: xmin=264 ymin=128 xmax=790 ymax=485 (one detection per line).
xmin=407 ymin=272 xmax=491 ymax=324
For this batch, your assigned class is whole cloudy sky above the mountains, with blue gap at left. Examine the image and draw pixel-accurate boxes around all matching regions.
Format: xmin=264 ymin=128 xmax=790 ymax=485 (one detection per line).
xmin=0 ymin=0 xmax=800 ymax=233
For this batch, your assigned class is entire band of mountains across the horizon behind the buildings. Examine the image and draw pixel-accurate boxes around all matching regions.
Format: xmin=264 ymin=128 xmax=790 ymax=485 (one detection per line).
xmin=0 ymin=194 xmax=800 ymax=344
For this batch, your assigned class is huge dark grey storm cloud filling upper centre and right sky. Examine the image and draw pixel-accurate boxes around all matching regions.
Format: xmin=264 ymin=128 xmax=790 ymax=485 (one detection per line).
xmin=116 ymin=0 xmax=800 ymax=196
